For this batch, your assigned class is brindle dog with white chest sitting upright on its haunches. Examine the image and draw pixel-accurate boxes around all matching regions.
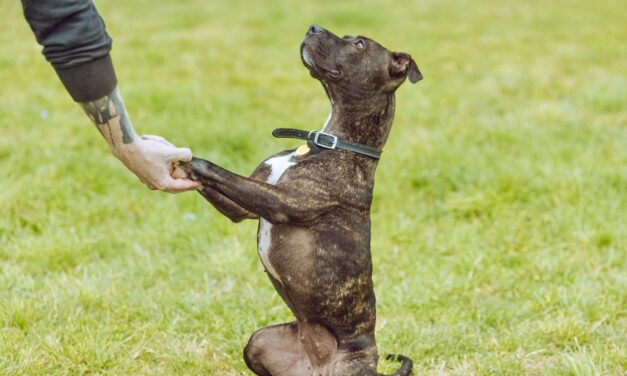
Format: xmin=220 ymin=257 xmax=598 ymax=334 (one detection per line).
xmin=181 ymin=25 xmax=422 ymax=376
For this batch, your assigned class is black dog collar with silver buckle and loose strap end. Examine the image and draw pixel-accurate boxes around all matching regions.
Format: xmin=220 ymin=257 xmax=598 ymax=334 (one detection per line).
xmin=272 ymin=128 xmax=381 ymax=159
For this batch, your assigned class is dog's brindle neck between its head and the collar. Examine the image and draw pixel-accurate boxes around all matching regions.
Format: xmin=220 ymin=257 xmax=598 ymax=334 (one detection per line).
xmin=324 ymin=88 xmax=395 ymax=149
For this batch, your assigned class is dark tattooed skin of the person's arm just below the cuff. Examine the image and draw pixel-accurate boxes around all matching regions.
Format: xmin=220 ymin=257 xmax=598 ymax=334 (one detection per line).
xmin=80 ymin=88 xmax=136 ymax=146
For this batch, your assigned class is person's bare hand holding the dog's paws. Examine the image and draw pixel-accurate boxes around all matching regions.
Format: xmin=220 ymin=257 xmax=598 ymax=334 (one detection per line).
xmin=111 ymin=135 xmax=200 ymax=193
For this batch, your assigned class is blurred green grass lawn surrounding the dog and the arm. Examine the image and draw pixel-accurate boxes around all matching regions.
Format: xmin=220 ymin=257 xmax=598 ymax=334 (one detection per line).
xmin=0 ymin=0 xmax=627 ymax=375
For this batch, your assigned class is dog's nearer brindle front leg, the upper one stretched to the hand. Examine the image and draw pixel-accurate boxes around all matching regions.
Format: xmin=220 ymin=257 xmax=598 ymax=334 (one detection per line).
xmin=181 ymin=158 xmax=338 ymax=223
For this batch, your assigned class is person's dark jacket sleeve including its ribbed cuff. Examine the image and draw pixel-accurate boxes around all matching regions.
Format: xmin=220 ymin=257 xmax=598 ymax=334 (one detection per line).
xmin=22 ymin=0 xmax=117 ymax=102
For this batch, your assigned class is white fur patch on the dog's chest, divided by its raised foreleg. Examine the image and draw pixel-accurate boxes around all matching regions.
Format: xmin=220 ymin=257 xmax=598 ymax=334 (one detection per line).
xmin=257 ymin=153 xmax=296 ymax=282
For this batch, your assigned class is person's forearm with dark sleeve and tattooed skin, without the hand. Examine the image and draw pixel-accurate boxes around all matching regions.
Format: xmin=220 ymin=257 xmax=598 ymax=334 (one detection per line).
xmin=22 ymin=0 xmax=136 ymax=157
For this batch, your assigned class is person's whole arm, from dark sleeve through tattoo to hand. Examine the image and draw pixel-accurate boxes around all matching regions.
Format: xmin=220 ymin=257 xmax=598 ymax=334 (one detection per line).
xmin=22 ymin=0 xmax=198 ymax=192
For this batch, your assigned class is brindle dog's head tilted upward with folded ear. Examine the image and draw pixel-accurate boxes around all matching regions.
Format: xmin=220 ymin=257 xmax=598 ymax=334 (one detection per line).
xmin=300 ymin=25 xmax=422 ymax=97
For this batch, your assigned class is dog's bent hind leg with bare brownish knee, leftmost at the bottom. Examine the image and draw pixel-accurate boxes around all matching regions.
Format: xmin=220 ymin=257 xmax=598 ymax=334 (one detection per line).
xmin=244 ymin=322 xmax=312 ymax=376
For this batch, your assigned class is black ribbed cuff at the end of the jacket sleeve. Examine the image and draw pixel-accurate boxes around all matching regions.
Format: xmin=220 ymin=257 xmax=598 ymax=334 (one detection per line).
xmin=55 ymin=54 xmax=118 ymax=102
